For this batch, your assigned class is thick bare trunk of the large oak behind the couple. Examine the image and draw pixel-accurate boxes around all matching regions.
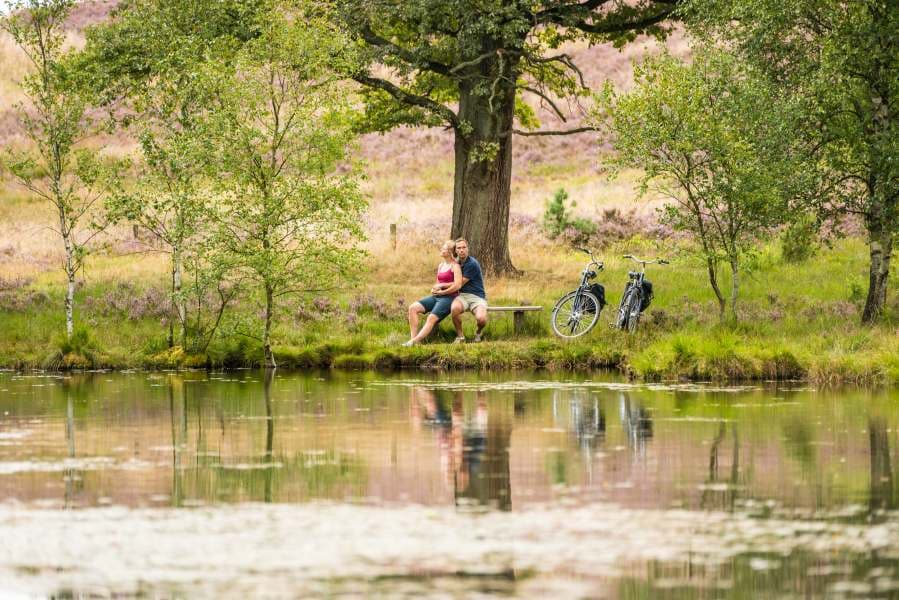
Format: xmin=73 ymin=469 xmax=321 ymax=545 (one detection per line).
xmin=451 ymin=72 xmax=517 ymax=275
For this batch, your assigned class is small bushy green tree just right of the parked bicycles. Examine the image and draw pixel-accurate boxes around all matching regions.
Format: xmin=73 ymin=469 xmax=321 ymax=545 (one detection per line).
xmin=599 ymin=48 xmax=802 ymax=317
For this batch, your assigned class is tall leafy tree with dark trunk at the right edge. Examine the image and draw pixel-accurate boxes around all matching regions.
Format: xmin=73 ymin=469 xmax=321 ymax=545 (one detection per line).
xmin=684 ymin=0 xmax=899 ymax=322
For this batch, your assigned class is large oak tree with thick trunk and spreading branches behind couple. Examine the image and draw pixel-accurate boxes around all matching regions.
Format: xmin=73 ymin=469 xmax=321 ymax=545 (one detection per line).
xmin=337 ymin=0 xmax=679 ymax=274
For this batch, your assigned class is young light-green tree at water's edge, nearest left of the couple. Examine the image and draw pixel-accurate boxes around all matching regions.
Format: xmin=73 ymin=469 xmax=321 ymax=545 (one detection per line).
xmin=203 ymin=9 xmax=365 ymax=364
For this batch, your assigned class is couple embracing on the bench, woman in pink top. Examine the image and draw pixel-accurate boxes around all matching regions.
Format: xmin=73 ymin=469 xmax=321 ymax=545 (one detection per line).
xmin=403 ymin=238 xmax=487 ymax=346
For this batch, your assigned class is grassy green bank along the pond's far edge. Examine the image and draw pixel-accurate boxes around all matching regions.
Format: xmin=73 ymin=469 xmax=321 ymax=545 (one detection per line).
xmin=0 ymin=232 xmax=899 ymax=384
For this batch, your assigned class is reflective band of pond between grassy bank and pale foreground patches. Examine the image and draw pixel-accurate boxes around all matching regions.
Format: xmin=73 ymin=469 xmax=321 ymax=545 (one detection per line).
xmin=0 ymin=372 xmax=899 ymax=513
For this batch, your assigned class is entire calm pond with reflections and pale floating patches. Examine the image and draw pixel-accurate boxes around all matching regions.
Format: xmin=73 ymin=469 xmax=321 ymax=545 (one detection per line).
xmin=0 ymin=371 xmax=899 ymax=598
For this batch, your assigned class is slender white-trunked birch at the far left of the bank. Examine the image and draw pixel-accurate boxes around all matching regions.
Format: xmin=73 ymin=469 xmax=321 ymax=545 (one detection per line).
xmin=0 ymin=0 xmax=122 ymax=336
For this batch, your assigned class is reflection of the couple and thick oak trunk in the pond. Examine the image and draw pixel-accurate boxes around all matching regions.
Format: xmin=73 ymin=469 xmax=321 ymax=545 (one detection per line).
xmin=409 ymin=386 xmax=515 ymax=511
